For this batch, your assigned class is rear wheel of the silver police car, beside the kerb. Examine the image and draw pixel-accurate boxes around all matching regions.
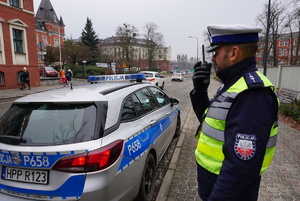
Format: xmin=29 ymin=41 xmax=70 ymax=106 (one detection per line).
xmin=136 ymin=154 xmax=156 ymax=201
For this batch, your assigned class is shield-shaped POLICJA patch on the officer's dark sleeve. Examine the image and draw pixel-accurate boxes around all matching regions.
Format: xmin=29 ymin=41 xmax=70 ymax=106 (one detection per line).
xmin=234 ymin=133 xmax=256 ymax=161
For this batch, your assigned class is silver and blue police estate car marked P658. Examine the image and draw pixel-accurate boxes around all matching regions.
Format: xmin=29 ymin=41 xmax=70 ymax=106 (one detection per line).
xmin=0 ymin=74 xmax=180 ymax=201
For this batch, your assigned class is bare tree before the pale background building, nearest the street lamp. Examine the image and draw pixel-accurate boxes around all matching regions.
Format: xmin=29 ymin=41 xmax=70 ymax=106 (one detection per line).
xmin=144 ymin=22 xmax=164 ymax=68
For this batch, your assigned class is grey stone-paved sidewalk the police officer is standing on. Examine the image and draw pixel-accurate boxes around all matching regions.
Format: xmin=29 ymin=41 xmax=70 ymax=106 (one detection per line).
xmin=156 ymin=79 xmax=300 ymax=201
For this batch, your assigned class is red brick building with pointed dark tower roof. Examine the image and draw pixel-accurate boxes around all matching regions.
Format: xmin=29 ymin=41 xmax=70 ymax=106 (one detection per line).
xmin=35 ymin=0 xmax=65 ymax=66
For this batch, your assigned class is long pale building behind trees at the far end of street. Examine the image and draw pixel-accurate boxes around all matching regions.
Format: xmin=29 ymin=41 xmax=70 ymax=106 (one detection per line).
xmin=99 ymin=37 xmax=171 ymax=72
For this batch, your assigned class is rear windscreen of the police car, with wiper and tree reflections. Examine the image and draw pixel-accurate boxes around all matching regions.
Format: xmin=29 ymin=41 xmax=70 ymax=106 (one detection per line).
xmin=0 ymin=103 xmax=97 ymax=146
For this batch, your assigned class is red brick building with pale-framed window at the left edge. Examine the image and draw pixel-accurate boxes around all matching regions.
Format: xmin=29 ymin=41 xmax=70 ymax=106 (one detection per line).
xmin=0 ymin=0 xmax=40 ymax=90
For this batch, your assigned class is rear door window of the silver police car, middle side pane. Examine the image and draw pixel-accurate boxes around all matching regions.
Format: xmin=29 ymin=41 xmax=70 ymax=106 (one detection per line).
xmin=135 ymin=88 xmax=157 ymax=113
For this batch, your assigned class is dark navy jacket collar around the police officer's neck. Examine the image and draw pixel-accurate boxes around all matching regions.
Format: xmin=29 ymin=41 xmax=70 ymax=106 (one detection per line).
xmin=217 ymin=57 xmax=257 ymax=86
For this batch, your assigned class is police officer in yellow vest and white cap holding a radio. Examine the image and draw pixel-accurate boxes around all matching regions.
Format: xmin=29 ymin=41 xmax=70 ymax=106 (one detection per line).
xmin=190 ymin=25 xmax=279 ymax=201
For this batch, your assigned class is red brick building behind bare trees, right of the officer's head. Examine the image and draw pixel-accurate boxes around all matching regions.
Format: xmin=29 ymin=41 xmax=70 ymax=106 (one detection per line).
xmin=256 ymin=32 xmax=300 ymax=66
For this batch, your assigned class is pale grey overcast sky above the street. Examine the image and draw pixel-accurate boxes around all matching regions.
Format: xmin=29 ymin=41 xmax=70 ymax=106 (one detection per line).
xmin=34 ymin=0 xmax=268 ymax=60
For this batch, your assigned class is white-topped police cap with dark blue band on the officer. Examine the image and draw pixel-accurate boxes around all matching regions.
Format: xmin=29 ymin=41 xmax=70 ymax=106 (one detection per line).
xmin=207 ymin=24 xmax=262 ymax=52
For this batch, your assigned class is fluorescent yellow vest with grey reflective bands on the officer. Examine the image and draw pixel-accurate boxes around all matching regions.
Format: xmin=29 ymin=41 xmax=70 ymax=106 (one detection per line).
xmin=195 ymin=71 xmax=279 ymax=174
